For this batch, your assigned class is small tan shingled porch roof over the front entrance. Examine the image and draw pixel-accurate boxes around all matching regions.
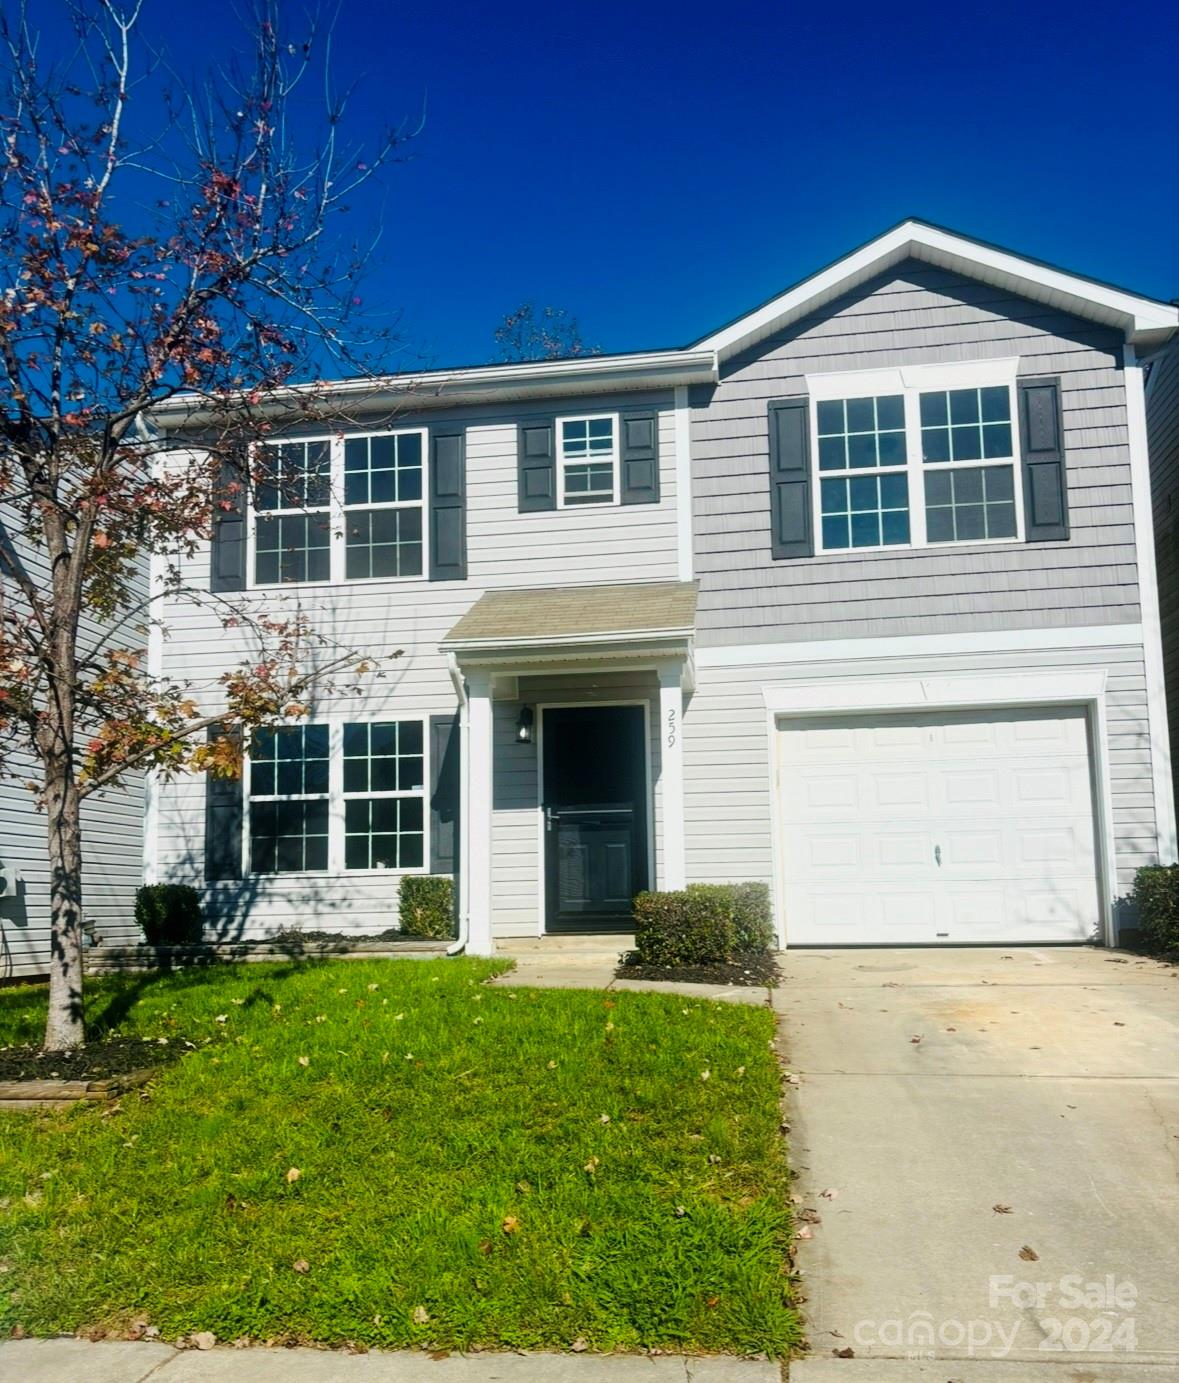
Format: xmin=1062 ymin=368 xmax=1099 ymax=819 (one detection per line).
xmin=440 ymin=581 xmax=696 ymax=667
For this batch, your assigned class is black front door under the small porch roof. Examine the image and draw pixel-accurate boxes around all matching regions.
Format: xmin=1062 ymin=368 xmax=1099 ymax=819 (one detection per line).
xmin=541 ymin=705 xmax=648 ymax=932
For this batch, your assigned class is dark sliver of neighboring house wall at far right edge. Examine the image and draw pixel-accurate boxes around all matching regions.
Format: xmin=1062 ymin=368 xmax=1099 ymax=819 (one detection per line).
xmin=1146 ymin=344 xmax=1179 ymax=824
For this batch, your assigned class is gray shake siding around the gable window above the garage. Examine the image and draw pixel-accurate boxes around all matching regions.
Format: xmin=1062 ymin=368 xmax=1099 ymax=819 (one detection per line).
xmin=692 ymin=261 xmax=1139 ymax=646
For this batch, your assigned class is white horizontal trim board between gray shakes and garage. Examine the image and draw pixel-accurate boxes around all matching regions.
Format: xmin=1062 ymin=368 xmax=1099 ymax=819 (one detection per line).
xmin=695 ymin=624 xmax=1143 ymax=668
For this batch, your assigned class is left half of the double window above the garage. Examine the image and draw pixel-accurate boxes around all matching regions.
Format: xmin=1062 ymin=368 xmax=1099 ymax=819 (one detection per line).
xmin=816 ymin=394 xmax=909 ymax=550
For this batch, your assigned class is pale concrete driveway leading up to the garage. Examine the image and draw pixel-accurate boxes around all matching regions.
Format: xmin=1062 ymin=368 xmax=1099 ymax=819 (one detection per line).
xmin=774 ymin=947 xmax=1179 ymax=1383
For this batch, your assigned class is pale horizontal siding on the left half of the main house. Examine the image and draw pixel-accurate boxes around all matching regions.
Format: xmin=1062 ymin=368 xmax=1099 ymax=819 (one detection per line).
xmin=155 ymin=391 xmax=678 ymax=936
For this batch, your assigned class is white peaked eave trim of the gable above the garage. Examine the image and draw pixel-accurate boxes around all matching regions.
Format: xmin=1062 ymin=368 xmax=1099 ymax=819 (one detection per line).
xmin=688 ymin=219 xmax=1179 ymax=360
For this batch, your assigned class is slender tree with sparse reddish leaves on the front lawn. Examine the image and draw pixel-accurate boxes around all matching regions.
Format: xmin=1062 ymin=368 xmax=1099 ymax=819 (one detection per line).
xmin=0 ymin=0 xmax=407 ymax=1050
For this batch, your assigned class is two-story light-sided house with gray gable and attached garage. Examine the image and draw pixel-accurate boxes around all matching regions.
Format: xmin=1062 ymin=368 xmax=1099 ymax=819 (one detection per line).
xmin=148 ymin=221 xmax=1179 ymax=953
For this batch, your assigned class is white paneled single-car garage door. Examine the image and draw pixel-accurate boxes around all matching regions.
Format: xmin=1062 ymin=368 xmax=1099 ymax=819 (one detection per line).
xmin=778 ymin=707 xmax=1100 ymax=946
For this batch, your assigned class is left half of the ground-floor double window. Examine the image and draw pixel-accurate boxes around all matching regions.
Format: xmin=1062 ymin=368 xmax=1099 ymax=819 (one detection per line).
xmin=249 ymin=725 xmax=329 ymax=874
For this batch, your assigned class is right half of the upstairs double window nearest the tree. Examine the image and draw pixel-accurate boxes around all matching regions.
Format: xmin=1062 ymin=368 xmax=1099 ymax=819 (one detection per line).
xmin=345 ymin=431 xmax=423 ymax=581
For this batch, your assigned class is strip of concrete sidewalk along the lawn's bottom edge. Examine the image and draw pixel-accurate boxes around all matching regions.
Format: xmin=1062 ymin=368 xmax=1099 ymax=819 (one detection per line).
xmin=0 ymin=1339 xmax=780 ymax=1383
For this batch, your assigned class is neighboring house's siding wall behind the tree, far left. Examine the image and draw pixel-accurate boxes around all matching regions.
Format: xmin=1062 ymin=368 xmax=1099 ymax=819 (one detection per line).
xmin=0 ymin=516 xmax=144 ymax=979
